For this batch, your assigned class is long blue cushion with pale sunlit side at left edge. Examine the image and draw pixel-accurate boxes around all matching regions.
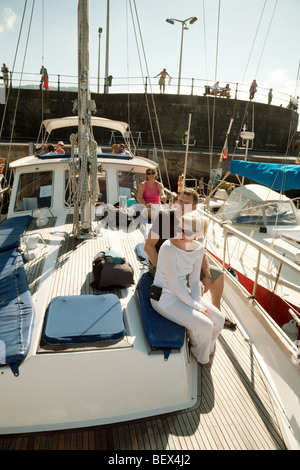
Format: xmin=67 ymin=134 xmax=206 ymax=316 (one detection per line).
xmin=0 ymin=248 xmax=34 ymax=365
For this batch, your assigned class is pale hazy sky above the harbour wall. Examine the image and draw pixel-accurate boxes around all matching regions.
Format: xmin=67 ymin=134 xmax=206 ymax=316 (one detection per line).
xmin=0 ymin=0 xmax=300 ymax=106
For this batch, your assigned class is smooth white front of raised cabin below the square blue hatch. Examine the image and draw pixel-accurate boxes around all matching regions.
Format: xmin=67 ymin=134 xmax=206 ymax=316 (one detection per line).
xmin=0 ymin=324 xmax=197 ymax=434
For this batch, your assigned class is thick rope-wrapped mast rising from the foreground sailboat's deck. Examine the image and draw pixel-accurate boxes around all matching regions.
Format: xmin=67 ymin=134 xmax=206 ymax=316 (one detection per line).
xmin=74 ymin=0 xmax=98 ymax=238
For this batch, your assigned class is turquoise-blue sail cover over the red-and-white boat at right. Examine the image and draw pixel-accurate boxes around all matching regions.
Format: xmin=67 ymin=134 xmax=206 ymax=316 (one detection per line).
xmin=229 ymin=160 xmax=300 ymax=191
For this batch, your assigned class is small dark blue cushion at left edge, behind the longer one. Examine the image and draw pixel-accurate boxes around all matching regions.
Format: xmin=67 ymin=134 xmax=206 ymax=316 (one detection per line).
xmin=0 ymin=215 xmax=31 ymax=253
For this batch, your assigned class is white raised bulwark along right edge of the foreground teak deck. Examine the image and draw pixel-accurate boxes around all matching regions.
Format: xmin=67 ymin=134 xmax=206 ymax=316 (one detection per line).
xmin=210 ymin=258 xmax=300 ymax=450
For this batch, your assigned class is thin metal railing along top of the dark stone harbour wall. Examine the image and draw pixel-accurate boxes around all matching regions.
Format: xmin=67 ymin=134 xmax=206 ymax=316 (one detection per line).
xmin=0 ymin=72 xmax=291 ymax=108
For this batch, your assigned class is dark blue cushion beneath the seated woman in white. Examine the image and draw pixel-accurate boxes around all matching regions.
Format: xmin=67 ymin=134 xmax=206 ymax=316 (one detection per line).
xmin=137 ymin=272 xmax=185 ymax=359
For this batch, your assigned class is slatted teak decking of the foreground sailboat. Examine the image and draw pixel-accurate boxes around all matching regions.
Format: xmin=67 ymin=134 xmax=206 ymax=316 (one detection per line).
xmin=0 ymin=215 xmax=285 ymax=450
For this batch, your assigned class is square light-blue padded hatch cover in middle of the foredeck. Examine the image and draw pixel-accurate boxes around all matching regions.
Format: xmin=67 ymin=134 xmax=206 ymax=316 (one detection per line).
xmin=43 ymin=294 xmax=126 ymax=344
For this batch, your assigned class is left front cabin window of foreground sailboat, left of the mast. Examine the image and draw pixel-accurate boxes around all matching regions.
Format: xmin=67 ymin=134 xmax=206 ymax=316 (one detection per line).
xmin=14 ymin=171 xmax=53 ymax=212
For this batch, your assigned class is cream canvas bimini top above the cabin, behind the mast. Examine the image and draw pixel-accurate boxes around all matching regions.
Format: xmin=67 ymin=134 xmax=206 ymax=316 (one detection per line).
xmin=42 ymin=116 xmax=129 ymax=134
